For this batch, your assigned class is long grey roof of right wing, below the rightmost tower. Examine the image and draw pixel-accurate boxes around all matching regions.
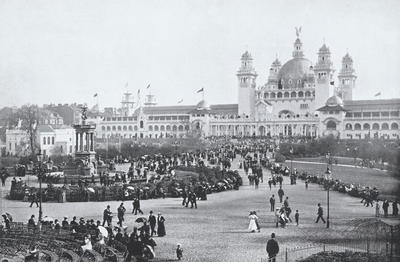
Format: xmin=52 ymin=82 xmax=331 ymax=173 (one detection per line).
xmin=344 ymin=98 xmax=400 ymax=111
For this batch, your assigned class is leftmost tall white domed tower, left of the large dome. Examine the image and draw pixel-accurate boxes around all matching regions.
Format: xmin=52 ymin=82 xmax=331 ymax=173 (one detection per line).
xmin=236 ymin=51 xmax=257 ymax=118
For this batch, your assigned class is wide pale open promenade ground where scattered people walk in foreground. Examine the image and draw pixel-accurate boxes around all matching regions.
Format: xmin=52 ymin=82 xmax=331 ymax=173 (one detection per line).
xmin=1 ymin=160 xmax=375 ymax=262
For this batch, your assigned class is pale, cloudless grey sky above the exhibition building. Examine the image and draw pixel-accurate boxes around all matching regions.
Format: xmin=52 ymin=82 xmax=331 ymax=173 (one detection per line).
xmin=0 ymin=0 xmax=400 ymax=107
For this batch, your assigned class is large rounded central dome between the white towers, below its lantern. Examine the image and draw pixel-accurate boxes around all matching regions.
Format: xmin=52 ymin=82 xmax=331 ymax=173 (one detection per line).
xmin=278 ymin=57 xmax=314 ymax=88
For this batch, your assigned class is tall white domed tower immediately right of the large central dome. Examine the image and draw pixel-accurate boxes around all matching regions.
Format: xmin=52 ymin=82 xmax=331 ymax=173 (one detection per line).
xmin=314 ymin=43 xmax=335 ymax=111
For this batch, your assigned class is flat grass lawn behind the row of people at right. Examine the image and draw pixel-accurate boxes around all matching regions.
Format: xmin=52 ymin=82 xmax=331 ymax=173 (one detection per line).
xmin=285 ymin=161 xmax=400 ymax=198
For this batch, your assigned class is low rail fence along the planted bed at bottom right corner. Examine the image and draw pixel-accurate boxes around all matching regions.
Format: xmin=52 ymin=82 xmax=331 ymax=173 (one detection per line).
xmin=260 ymin=240 xmax=400 ymax=262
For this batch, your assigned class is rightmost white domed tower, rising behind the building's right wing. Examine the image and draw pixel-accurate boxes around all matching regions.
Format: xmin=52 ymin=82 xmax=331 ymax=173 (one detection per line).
xmin=338 ymin=53 xmax=357 ymax=100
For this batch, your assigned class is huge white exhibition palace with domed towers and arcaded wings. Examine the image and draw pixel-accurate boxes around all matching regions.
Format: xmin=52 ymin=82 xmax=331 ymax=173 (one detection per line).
xmin=96 ymin=30 xmax=400 ymax=139
